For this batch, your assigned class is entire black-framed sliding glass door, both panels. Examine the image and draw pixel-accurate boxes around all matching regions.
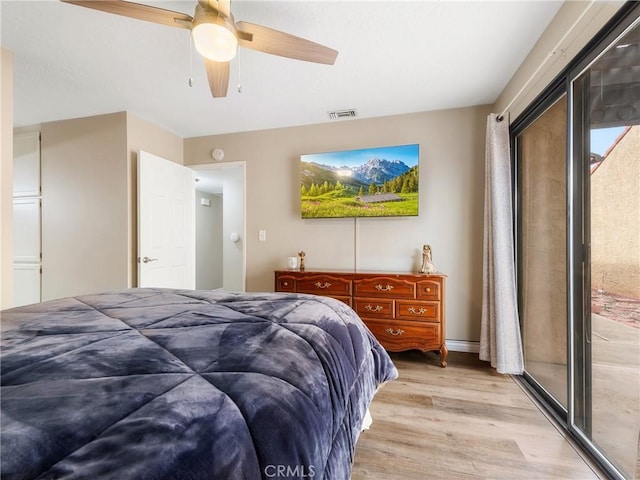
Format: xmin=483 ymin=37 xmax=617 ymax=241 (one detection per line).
xmin=512 ymin=3 xmax=640 ymax=479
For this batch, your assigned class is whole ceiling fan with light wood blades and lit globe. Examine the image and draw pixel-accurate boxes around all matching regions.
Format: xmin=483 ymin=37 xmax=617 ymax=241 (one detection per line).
xmin=61 ymin=0 xmax=338 ymax=97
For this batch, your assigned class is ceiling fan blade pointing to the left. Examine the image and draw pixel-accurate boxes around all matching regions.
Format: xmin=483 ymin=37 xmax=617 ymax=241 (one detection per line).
xmin=60 ymin=0 xmax=193 ymax=29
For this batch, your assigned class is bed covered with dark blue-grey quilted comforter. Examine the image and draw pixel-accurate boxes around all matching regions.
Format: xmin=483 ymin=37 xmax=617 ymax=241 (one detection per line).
xmin=1 ymin=289 xmax=397 ymax=480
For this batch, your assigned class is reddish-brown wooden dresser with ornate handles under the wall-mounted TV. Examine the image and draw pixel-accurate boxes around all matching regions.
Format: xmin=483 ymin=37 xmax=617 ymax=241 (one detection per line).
xmin=275 ymin=270 xmax=448 ymax=367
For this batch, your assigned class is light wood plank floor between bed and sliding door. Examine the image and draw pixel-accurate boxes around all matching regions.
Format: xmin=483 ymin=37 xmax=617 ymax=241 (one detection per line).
xmin=352 ymin=352 xmax=600 ymax=480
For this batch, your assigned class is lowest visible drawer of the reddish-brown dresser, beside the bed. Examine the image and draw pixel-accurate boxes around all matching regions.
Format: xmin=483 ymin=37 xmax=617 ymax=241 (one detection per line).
xmin=365 ymin=319 xmax=442 ymax=352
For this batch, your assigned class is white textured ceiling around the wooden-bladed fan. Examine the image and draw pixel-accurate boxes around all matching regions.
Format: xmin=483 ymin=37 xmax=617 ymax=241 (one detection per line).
xmin=0 ymin=0 xmax=562 ymax=138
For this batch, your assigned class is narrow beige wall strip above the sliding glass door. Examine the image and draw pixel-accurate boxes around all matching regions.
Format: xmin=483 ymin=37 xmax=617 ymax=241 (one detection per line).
xmin=493 ymin=0 xmax=625 ymax=121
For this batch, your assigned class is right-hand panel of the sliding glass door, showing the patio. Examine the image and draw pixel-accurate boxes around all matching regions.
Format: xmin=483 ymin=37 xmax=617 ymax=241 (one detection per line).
xmin=571 ymin=16 xmax=640 ymax=478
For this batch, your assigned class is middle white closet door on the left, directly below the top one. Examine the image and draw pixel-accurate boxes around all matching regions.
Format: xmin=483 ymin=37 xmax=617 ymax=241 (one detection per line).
xmin=13 ymin=198 xmax=40 ymax=263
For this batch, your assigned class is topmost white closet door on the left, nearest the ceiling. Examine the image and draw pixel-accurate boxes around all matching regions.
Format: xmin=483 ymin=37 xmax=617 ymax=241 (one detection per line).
xmin=13 ymin=132 xmax=40 ymax=197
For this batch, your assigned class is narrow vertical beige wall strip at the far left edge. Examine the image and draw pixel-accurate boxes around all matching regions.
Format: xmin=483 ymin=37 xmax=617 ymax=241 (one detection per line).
xmin=0 ymin=49 xmax=13 ymax=309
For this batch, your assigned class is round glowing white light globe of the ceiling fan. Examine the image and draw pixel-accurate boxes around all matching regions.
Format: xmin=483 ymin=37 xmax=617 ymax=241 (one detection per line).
xmin=191 ymin=12 xmax=238 ymax=62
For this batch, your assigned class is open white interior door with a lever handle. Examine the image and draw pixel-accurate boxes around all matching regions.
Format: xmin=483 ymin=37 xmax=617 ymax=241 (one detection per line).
xmin=138 ymin=151 xmax=196 ymax=289
